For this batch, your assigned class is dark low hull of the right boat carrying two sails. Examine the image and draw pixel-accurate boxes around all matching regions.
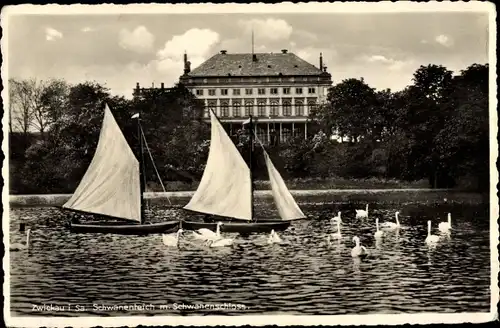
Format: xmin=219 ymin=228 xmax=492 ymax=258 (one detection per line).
xmin=182 ymin=221 xmax=290 ymax=233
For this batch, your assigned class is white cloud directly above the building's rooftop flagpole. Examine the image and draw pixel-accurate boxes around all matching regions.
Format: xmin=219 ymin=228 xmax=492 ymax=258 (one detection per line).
xmin=238 ymin=18 xmax=293 ymax=41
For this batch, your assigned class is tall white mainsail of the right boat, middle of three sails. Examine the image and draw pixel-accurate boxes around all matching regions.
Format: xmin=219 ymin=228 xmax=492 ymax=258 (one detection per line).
xmin=184 ymin=111 xmax=252 ymax=220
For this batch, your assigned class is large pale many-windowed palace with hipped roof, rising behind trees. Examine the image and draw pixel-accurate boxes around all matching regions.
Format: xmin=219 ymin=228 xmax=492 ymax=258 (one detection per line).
xmin=180 ymin=50 xmax=332 ymax=143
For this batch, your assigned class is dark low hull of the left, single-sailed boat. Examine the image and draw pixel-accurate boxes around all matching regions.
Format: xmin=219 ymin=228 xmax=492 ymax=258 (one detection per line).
xmin=69 ymin=221 xmax=179 ymax=235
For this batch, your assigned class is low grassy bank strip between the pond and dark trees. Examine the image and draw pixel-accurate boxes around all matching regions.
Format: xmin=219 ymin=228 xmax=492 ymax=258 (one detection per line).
xmin=10 ymin=188 xmax=488 ymax=207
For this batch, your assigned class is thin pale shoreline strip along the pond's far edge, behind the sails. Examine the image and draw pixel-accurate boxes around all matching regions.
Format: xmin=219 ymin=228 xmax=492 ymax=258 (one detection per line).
xmin=8 ymin=188 xmax=490 ymax=207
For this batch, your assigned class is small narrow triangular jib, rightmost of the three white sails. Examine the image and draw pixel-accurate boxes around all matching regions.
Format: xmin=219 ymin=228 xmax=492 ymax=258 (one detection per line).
xmin=264 ymin=150 xmax=306 ymax=220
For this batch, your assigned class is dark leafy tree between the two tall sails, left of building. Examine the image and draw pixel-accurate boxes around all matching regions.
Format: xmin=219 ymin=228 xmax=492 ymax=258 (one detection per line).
xmin=130 ymin=84 xmax=209 ymax=181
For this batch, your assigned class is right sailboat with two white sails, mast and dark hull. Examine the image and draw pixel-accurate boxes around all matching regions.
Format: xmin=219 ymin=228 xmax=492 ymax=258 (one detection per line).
xmin=182 ymin=110 xmax=306 ymax=233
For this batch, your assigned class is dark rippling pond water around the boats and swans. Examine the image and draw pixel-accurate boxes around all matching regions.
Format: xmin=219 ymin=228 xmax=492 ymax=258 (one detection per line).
xmin=10 ymin=200 xmax=490 ymax=316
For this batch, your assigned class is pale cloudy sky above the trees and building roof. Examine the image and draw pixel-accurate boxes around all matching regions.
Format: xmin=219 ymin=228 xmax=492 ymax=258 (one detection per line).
xmin=6 ymin=6 xmax=488 ymax=98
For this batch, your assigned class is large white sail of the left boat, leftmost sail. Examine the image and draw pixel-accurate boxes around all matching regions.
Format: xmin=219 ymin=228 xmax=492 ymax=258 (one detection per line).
xmin=63 ymin=105 xmax=141 ymax=221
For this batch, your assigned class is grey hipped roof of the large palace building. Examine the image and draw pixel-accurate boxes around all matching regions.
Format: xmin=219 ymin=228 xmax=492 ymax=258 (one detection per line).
xmin=188 ymin=53 xmax=323 ymax=77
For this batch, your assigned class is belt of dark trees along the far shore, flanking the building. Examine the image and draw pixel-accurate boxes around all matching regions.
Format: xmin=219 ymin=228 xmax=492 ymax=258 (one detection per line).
xmin=5 ymin=64 xmax=489 ymax=193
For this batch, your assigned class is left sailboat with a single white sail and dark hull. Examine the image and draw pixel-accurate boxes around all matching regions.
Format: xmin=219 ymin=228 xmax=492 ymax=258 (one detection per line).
xmin=62 ymin=104 xmax=179 ymax=235
